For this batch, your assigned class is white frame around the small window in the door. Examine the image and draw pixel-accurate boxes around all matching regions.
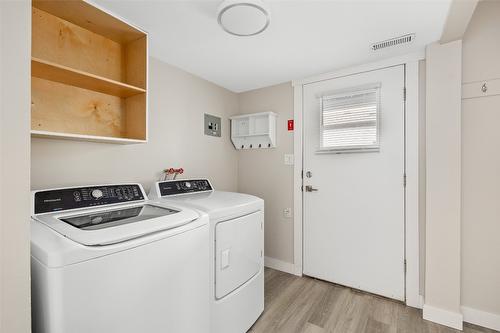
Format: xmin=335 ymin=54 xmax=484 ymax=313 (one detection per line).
xmin=316 ymin=83 xmax=382 ymax=154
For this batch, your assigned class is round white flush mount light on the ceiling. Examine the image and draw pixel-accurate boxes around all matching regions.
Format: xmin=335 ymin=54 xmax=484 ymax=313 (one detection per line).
xmin=217 ymin=0 xmax=270 ymax=36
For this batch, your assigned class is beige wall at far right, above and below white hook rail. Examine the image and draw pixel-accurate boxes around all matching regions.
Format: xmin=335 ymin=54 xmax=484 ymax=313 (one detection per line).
xmin=462 ymin=1 xmax=500 ymax=316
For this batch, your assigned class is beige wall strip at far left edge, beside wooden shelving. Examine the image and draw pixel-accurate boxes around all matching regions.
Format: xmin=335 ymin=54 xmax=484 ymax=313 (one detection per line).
xmin=0 ymin=1 xmax=31 ymax=333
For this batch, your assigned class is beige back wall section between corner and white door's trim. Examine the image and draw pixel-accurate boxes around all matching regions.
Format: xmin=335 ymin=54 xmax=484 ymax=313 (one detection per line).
xmin=238 ymin=82 xmax=293 ymax=263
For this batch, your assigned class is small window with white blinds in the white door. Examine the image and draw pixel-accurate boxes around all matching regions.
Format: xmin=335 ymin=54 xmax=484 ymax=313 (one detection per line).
xmin=320 ymin=86 xmax=380 ymax=152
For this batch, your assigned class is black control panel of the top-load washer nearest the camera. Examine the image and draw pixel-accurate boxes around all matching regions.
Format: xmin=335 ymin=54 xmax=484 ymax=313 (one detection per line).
xmin=34 ymin=184 xmax=145 ymax=214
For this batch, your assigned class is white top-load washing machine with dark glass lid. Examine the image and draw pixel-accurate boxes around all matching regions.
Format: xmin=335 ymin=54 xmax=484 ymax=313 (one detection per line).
xmin=31 ymin=184 xmax=209 ymax=333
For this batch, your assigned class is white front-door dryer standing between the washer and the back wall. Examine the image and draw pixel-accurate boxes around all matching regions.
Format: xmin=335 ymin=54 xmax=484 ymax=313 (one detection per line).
xmin=149 ymin=179 xmax=264 ymax=333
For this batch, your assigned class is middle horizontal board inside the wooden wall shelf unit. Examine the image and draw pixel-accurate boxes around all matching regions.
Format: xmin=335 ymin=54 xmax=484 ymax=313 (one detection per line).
xmin=31 ymin=57 xmax=146 ymax=97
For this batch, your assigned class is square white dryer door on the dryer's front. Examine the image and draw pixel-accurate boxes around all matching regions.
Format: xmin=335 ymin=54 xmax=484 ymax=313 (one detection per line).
xmin=215 ymin=211 xmax=264 ymax=299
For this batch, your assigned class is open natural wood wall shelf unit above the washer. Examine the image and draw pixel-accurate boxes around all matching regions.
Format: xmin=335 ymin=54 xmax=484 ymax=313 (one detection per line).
xmin=31 ymin=0 xmax=147 ymax=143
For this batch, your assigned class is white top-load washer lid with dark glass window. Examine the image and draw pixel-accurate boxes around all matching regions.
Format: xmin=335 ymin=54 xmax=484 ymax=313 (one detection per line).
xmin=34 ymin=202 xmax=199 ymax=246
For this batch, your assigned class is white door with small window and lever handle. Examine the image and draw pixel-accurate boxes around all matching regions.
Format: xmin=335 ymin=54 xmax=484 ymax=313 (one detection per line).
xmin=303 ymin=65 xmax=405 ymax=300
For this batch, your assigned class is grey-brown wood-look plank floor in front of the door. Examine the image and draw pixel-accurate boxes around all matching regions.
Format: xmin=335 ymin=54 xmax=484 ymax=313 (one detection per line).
xmin=249 ymin=268 xmax=497 ymax=333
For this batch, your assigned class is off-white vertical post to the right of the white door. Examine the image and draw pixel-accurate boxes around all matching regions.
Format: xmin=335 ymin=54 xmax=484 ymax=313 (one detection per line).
xmin=424 ymin=41 xmax=462 ymax=318
